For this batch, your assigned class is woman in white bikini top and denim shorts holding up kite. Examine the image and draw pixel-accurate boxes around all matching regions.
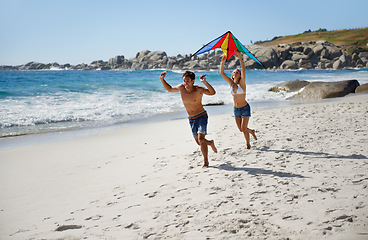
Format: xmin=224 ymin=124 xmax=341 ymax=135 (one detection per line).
xmin=220 ymin=52 xmax=257 ymax=149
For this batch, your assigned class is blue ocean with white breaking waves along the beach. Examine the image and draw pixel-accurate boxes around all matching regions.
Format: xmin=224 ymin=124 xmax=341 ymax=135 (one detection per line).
xmin=0 ymin=68 xmax=368 ymax=138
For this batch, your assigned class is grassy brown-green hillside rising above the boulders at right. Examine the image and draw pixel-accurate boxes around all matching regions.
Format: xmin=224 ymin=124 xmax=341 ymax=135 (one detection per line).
xmin=256 ymin=28 xmax=368 ymax=54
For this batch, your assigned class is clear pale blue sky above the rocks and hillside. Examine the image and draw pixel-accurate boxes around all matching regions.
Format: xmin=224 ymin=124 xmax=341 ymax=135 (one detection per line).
xmin=0 ymin=0 xmax=368 ymax=65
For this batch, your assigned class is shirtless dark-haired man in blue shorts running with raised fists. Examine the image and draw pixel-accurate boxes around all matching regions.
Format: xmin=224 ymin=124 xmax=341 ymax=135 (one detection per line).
xmin=160 ymin=71 xmax=217 ymax=168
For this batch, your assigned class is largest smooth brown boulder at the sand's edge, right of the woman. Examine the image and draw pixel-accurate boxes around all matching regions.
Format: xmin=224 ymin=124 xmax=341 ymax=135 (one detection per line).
xmin=288 ymin=80 xmax=359 ymax=99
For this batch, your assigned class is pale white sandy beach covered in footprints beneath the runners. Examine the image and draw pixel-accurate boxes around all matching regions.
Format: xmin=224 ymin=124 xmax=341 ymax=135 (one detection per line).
xmin=0 ymin=95 xmax=368 ymax=239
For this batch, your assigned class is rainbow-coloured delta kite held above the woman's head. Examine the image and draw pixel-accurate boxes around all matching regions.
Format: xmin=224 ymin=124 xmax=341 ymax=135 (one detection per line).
xmin=193 ymin=31 xmax=264 ymax=67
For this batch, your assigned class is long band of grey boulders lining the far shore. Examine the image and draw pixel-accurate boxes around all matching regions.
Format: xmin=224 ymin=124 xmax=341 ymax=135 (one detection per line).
xmin=0 ymin=41 xmax=368 ymax=70
